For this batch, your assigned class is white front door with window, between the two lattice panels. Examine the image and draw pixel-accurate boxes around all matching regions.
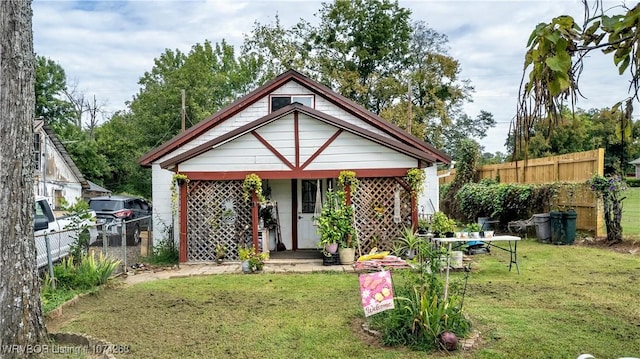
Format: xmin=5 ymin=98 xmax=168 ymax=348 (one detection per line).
xmin=297 ymin=179 xmax=326 ymax=249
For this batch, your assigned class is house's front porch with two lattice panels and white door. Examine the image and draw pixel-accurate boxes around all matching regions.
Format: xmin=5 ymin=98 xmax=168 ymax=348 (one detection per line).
xmin=180 ymin=176 xmax=417 ymax=263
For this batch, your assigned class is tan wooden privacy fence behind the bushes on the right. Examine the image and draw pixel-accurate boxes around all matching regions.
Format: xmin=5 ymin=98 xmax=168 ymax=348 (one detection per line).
xmin=438 ymin=148 xmax=605 ymax=236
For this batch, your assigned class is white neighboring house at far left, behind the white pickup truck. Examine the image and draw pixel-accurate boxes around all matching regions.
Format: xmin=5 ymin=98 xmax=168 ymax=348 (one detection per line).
xmin=33 ymin=119 xmax=90 ymax=210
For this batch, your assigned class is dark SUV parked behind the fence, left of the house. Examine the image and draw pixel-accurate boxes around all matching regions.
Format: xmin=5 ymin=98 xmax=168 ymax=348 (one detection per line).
xmin=89 ymin=196 xmax=152 ymax=246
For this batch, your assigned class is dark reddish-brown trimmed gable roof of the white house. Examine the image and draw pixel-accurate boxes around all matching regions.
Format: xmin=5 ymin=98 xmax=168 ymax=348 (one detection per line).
xmin=138 ymin=70 xmax=451 ymax=166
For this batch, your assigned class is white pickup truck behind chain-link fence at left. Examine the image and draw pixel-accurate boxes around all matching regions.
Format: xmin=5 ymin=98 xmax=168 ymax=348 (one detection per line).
xmin=34 ymin=197 xmax=98 ymax=268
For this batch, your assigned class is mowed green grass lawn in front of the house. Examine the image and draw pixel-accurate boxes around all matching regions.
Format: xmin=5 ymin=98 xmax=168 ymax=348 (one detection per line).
xmin=48 ymin=240 xmax=640 ymax=358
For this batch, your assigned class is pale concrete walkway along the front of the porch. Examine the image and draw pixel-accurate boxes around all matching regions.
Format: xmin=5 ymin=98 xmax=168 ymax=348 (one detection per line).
xmin=121 ymin=259 xmax=354 ymax=285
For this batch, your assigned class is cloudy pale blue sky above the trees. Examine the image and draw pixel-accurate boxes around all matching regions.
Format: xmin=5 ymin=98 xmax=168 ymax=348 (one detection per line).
xmin=32 ymin=0 xmax=640 ymax=153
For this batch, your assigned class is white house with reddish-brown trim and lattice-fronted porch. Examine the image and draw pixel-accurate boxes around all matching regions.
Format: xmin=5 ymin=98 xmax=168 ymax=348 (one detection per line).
xmin=139 ymin=70 xmax=451 ymax=262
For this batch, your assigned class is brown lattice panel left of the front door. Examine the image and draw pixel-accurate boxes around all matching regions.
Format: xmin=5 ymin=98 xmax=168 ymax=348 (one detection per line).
xmin=187 ymin=181 xmax=251 ymax=261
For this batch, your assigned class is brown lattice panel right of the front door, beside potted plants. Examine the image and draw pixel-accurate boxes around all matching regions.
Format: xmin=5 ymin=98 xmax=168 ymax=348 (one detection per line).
xmin=352 ymin=178 xmax=411 ymax=253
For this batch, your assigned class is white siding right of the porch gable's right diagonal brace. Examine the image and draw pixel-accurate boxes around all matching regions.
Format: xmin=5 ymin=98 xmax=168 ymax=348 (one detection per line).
xmin=307 ymin=132 xmax=418 ymax=170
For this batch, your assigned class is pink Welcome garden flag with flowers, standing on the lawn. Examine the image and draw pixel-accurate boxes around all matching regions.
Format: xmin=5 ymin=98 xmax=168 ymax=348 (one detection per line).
xmin=360 ymin=271 xmax=394 ymax=317
